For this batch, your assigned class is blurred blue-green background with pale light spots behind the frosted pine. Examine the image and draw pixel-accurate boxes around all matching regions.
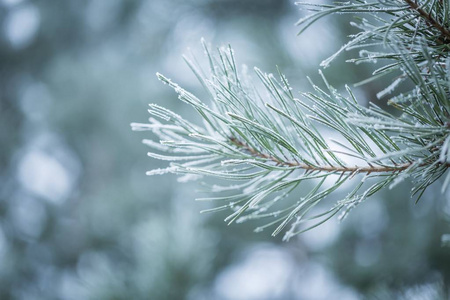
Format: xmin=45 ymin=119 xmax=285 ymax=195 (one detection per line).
xmin=0 ymin=0 xmax=450 ymax=300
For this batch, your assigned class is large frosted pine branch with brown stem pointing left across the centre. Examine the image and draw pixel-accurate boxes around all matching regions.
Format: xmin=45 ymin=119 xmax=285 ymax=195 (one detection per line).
xmin=132 ymin=39 xmax=450 ymax=240
